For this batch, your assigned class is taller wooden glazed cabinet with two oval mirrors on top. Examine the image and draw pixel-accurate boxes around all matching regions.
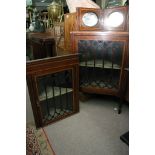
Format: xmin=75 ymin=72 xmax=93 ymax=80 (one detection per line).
xmin=71 ymin=7 xmax=129 ymax=113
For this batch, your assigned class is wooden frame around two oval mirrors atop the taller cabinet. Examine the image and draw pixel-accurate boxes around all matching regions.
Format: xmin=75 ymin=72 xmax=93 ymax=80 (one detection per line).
xmin=76 ymin=6 xmax=129 ymax=32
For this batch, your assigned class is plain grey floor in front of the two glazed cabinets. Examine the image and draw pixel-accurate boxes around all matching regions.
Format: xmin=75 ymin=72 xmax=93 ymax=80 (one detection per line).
xmin=44 ymin=96 xmax=129 ymax=155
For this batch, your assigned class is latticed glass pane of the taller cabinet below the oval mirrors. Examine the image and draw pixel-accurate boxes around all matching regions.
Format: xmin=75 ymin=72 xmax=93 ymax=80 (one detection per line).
xmin=78 ymin=40 xmax=124 ymax=89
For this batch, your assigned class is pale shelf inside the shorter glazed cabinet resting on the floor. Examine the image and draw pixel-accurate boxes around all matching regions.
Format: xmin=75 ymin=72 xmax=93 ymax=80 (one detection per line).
xmin=39 ymin=87 xmax=73 ymax=101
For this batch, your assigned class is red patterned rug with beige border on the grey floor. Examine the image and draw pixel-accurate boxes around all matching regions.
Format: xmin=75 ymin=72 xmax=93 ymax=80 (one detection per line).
xmin=26 ymin=124 xmax=55 ymax=155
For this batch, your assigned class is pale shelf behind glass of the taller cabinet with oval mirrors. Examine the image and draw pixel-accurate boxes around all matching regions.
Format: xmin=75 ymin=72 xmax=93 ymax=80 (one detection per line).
xmin=80 ymin=60 xmax=120 ymax=69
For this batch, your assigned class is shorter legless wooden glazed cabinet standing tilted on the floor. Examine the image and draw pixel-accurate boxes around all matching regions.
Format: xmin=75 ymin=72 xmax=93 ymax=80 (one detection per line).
xmin=26 ymin=54 xmax=79 ymax=127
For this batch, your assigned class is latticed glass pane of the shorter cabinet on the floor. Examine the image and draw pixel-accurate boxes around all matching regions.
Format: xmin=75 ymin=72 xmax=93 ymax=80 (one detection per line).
xmin=37 ymin=70 xmax=73 ymax=123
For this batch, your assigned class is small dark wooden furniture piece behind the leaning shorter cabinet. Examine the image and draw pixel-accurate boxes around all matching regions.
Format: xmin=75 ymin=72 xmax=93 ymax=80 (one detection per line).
xmin=27 ymin=33 xmax=56 ymax=59
